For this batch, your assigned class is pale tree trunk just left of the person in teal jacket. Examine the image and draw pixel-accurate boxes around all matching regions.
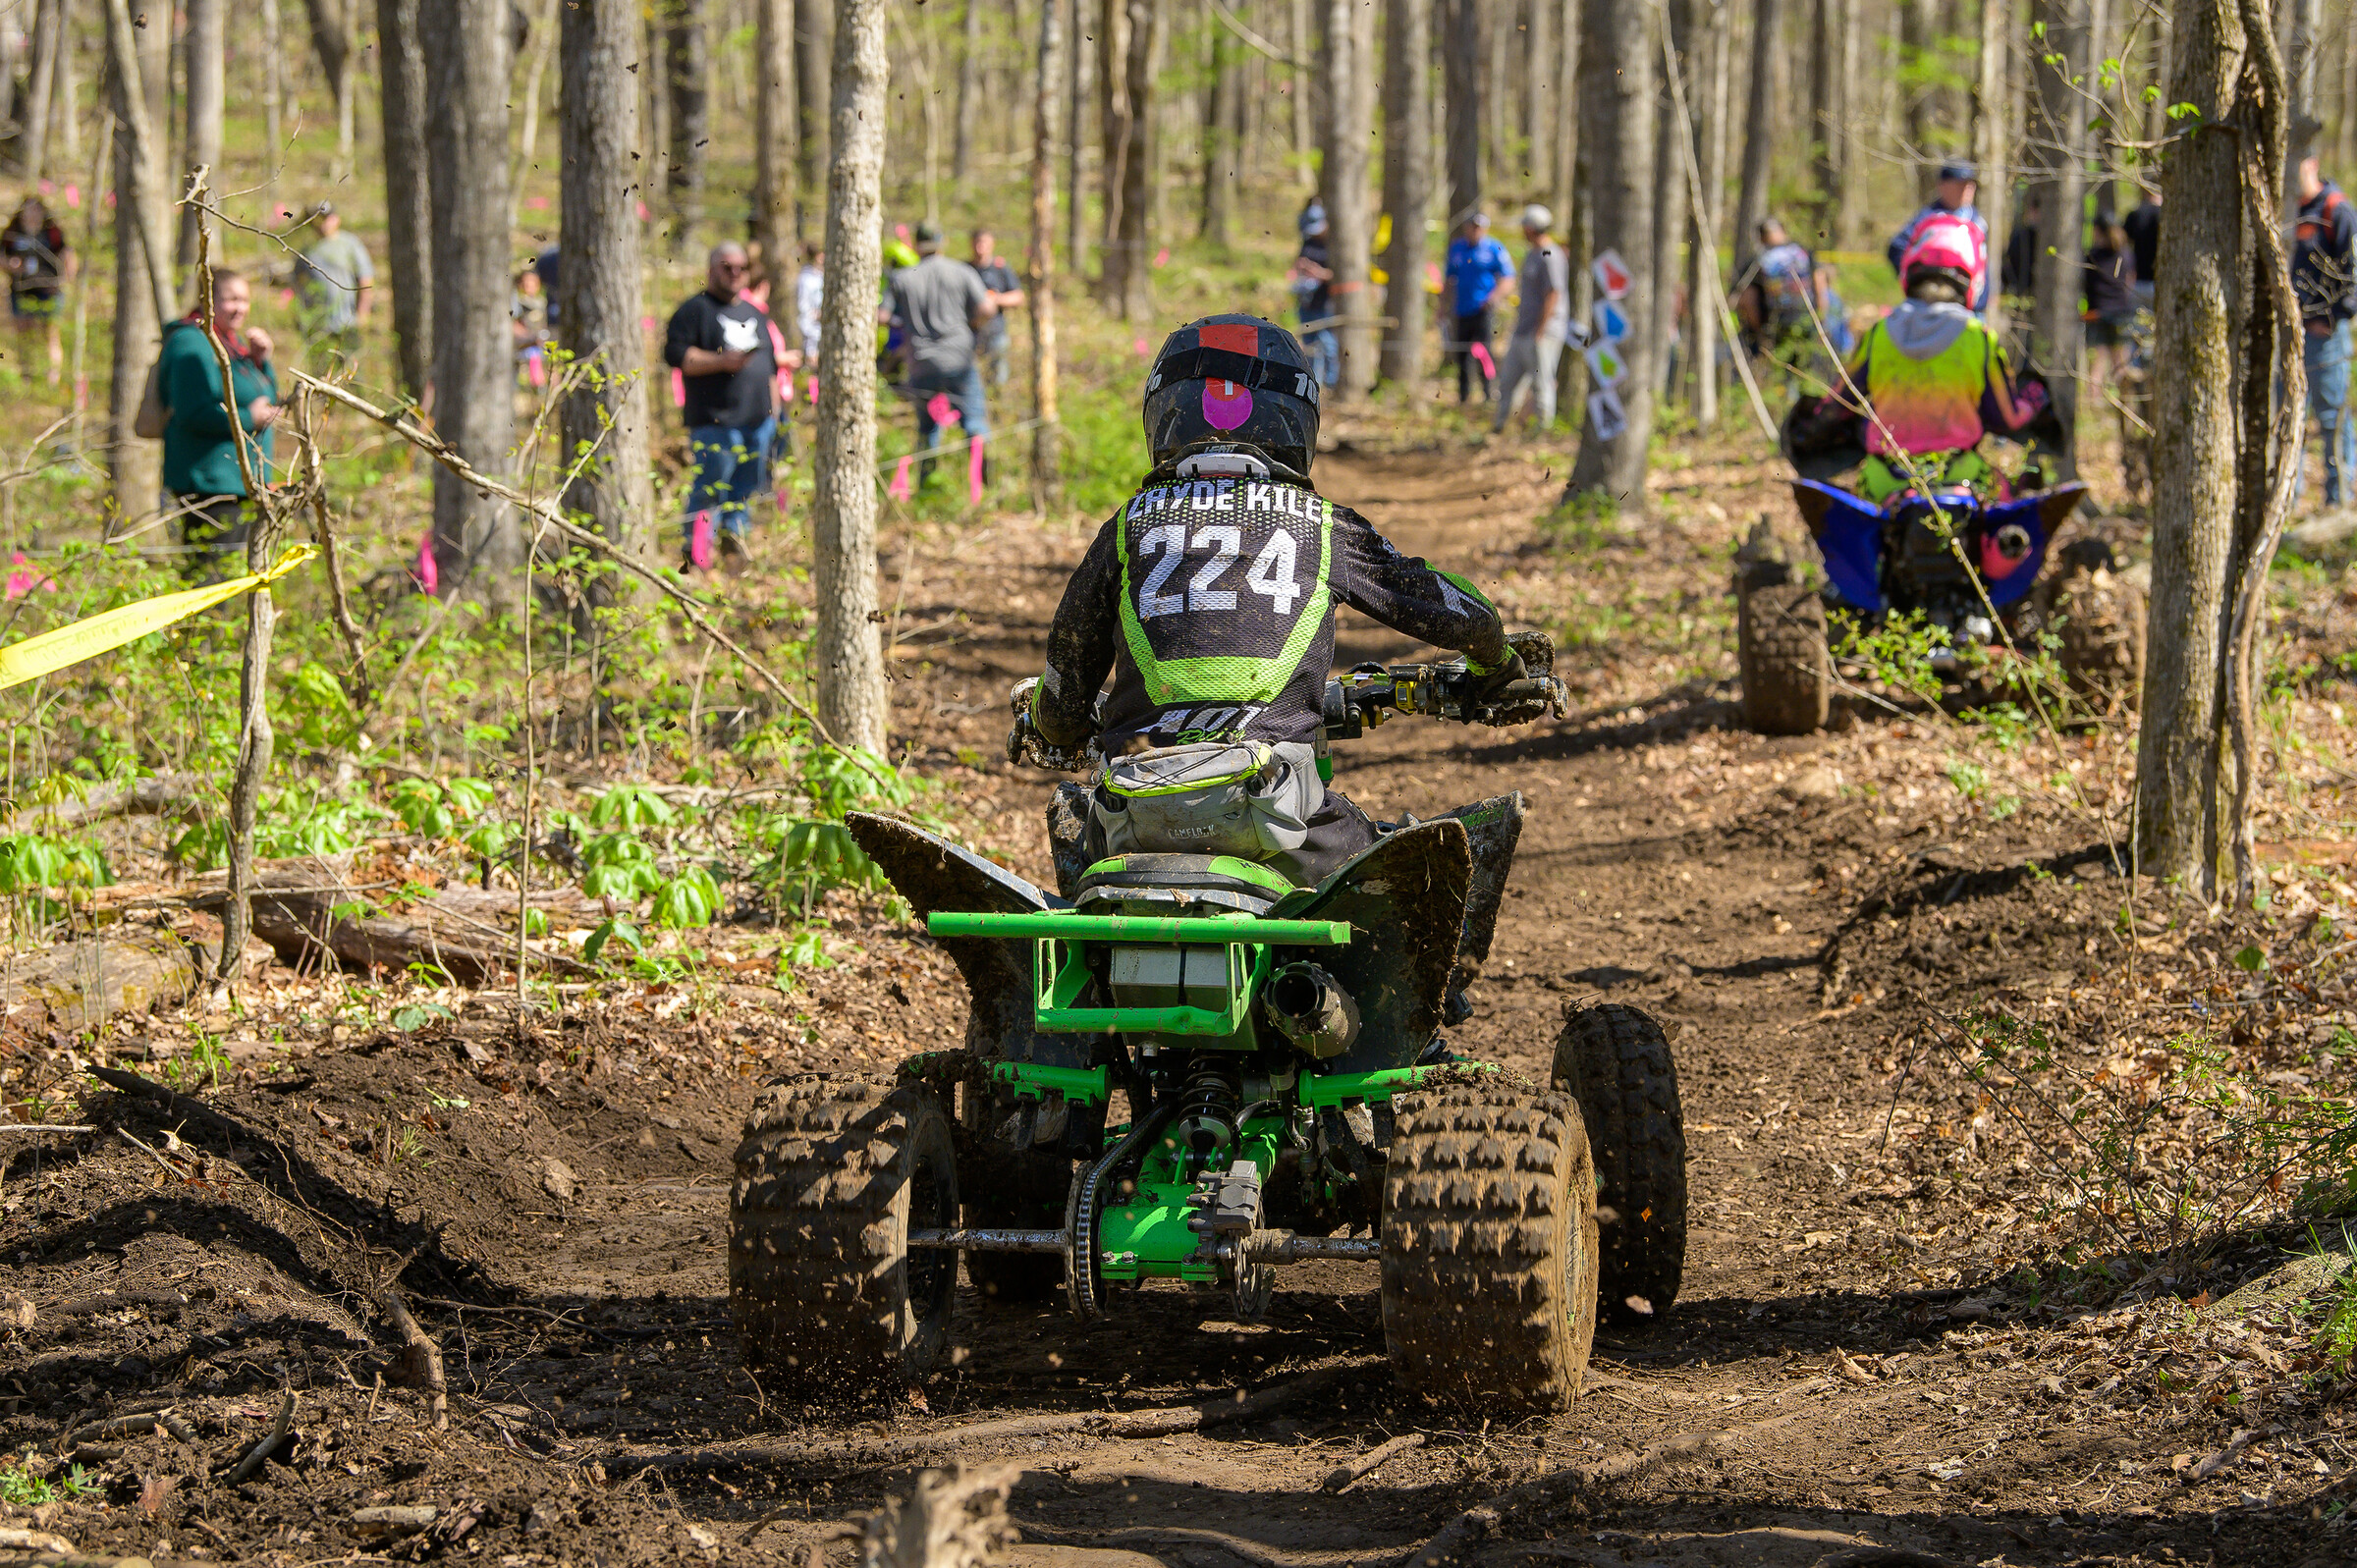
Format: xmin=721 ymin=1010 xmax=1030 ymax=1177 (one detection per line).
xmin=102 ymin=0 xmax=175 ymax=523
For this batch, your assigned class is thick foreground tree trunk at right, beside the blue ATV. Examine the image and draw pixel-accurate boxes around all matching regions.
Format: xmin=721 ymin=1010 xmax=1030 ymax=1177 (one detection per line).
xmin=2135 ymin=0 xmax=2305 ymax=898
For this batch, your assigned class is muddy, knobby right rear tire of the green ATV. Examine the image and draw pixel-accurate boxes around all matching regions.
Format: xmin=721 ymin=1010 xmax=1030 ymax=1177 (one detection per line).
xmin=1381 ymin=1087 xmax=1596 ymax=1410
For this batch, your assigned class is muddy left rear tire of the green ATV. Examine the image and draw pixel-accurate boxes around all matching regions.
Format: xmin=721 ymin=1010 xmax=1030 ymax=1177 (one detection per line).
xmin=729 ymin=1073 xmax=957 ymax=1388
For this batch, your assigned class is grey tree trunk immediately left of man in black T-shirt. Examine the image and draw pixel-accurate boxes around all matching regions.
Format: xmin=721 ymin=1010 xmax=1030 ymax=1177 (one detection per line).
xmin=556 ymin=0 xmax=655 ymax=566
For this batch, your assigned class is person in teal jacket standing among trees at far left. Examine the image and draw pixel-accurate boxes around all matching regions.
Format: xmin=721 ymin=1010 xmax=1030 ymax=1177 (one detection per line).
xmin=155 ymin=271 xmax=278 ymax=580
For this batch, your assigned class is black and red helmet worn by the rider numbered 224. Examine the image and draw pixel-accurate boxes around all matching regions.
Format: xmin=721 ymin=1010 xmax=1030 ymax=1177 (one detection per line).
xmin=1145 ymin=316 xmax=1318 ymax=479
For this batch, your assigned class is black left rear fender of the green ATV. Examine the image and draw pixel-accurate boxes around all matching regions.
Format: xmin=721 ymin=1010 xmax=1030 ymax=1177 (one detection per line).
xmin=844 ymin=811 xmax=1094 ymax=1068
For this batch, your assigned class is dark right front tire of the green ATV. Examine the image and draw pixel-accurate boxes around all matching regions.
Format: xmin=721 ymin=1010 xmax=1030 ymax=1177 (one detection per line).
xmin=1554 ymin=1002 xmax=1685 ymax=1323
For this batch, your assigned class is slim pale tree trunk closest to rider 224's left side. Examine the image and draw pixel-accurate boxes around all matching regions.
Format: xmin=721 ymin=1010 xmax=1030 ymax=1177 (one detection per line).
xmin=811 ymin=0 xmax=889 ymax=757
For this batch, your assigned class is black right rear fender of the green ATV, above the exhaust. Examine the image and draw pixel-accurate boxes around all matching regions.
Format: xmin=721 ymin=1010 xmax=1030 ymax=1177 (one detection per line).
xmin=1271 ymin=802 xmax=1461 ymax=1073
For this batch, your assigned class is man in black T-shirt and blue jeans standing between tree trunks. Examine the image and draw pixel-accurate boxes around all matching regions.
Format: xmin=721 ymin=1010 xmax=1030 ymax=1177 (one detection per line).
xmin=662 ymin=241 xmax=778 ymax=575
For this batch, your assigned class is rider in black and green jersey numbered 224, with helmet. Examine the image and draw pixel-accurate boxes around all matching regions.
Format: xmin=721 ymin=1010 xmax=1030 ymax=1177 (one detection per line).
xmin=1012 ymin=316 xmax=1525 ymax=885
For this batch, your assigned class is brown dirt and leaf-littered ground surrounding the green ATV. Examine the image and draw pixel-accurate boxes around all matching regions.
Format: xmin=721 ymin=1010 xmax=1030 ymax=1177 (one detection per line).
xmin=0 ymin=424 xmax=2357 ymax=1568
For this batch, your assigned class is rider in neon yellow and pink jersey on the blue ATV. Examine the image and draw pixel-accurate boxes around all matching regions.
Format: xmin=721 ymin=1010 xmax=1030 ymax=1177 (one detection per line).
xmin=1840 ymin=222 xmax=2046 ymax=505
